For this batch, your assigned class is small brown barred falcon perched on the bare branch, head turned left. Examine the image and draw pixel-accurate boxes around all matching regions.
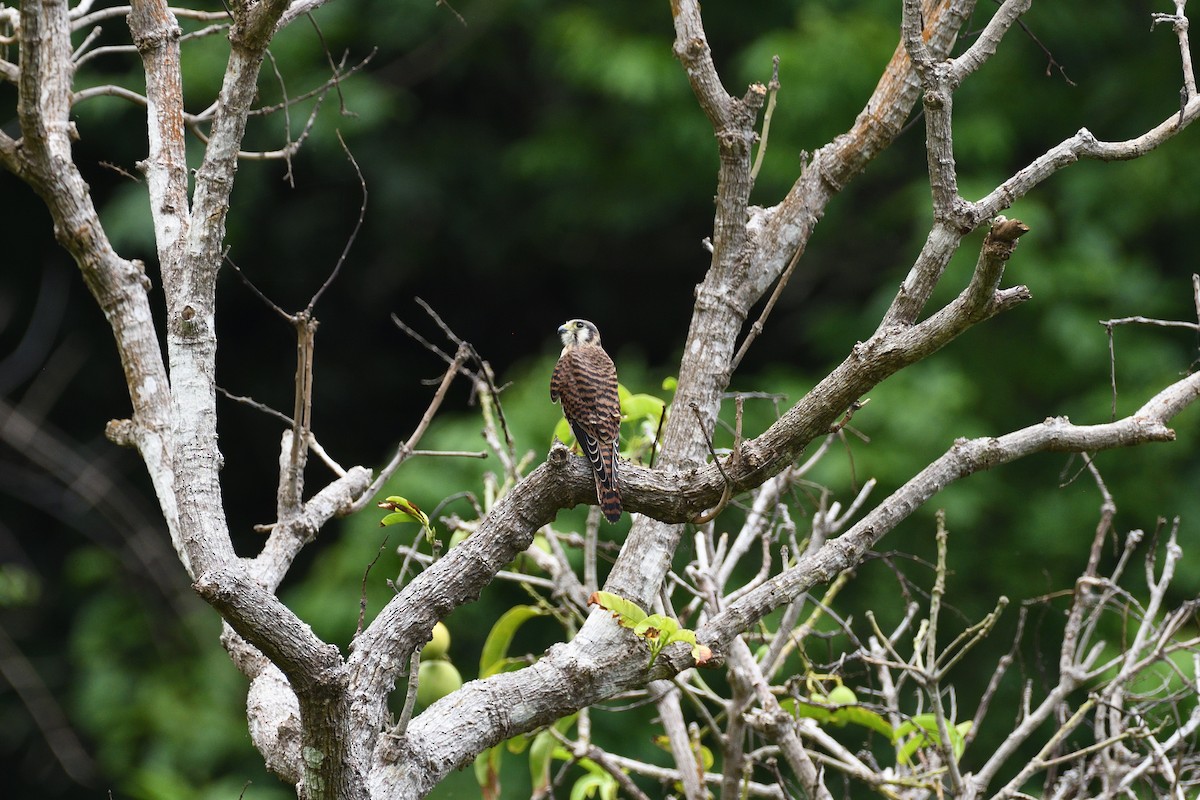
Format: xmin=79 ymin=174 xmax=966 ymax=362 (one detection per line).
xmin=550 ymin=319 xmax=620 ymax=522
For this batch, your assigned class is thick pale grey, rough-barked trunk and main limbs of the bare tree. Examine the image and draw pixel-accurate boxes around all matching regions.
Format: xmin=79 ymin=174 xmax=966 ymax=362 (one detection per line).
xmin=0 ymin=0 xmax=1200 ymax=800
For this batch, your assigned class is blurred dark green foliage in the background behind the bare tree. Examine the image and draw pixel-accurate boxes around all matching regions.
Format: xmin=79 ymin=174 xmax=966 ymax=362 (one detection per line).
xmin=0 ymin=0 xmax=1200 ymax=800
